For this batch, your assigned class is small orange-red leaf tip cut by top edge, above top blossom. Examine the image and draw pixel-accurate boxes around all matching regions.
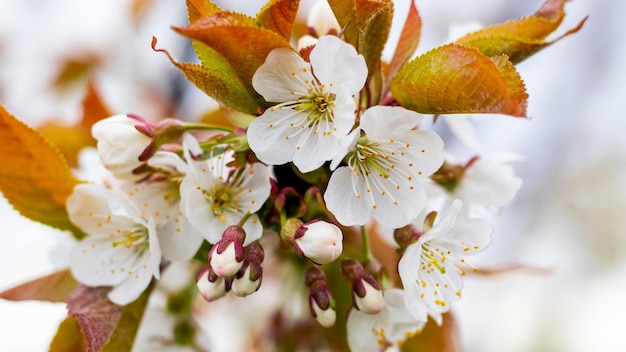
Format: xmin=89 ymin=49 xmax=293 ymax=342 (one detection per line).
xmin=256 ymin=0 xmax=300 ymax=39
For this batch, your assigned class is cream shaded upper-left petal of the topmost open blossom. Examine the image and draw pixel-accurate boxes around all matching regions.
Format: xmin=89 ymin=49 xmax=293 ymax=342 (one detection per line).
xmin=252 ymin=48 xmax=314 ymax=103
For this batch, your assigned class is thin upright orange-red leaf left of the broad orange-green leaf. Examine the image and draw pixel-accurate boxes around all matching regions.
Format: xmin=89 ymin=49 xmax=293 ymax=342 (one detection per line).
xmin=382 ymin=1 xmax=422 ymax=98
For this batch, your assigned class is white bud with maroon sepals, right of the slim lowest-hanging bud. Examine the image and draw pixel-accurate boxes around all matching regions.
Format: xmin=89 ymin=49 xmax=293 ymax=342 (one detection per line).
xmin=341 ymin=259 xmax=383 ymax=314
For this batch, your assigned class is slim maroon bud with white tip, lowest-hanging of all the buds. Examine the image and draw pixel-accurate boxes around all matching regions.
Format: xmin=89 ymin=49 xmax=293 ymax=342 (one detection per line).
xmin=304 ymin=268 xmax=337 ymax=328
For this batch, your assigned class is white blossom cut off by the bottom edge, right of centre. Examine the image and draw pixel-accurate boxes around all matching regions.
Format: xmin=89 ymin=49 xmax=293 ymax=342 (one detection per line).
xmin=347 ymin=288 xmax=426 ymax=352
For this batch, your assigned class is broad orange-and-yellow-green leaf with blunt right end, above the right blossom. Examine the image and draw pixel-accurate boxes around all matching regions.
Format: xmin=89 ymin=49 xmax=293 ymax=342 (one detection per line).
xmin=391 ymin=44 xmax=528 ymax=117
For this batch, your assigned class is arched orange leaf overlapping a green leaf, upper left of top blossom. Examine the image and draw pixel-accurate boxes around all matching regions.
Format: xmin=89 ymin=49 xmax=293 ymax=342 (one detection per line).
xmin=174 ymin=12 xmax=291 ymax=113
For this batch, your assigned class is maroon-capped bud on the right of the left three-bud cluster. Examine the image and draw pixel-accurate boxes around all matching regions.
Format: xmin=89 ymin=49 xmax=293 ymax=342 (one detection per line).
xmin=231 ymin=242 xmax=265 ymax=297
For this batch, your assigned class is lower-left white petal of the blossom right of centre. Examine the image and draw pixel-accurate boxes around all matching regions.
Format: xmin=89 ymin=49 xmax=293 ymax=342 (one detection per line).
xmin=324 ymin=166 xmax=373 ymax=226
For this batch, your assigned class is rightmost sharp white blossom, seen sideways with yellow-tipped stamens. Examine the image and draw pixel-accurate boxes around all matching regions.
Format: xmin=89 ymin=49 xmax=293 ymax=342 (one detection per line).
xmin=398 ymin=200 xmax=492 ymax=325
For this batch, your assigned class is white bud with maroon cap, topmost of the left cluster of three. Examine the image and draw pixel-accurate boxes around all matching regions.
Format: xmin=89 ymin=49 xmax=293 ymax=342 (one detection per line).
xmin=209 ymin=225 xmax=246 ymax=277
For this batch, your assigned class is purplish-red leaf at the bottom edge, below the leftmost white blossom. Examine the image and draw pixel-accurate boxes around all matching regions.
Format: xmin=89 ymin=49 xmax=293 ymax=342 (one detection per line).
xmin=67 ymin=285 xmax=123 ymax=352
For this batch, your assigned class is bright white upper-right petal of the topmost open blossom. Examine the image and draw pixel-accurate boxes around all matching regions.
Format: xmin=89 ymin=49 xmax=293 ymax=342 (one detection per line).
xmin=310 ymin=35 xmax=367 ymax=95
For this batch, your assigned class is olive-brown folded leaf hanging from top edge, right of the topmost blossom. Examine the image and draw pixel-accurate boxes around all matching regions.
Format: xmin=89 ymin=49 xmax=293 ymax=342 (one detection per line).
xmin=328 ymin=0 xmax=393 ymax=106
